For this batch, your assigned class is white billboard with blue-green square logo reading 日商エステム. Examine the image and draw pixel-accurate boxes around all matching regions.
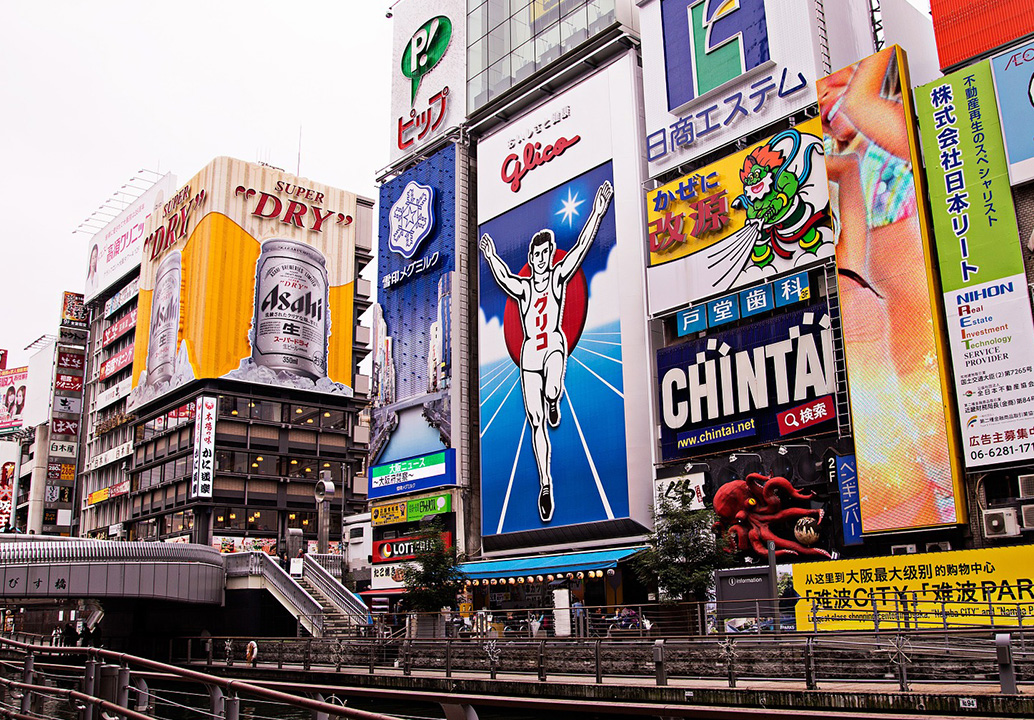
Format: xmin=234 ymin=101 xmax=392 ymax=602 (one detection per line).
xmin=639 ymin=0 xmax=817 ymax=176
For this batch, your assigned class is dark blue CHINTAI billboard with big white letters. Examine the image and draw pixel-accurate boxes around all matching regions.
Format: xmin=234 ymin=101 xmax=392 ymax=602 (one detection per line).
xmin=657 ymin=304 xmax=837 ymax=460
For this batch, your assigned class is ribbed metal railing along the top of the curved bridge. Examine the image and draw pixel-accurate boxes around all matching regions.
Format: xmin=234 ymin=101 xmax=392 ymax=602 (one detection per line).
xmin=0 ymin=536 xmax=223 ymax=568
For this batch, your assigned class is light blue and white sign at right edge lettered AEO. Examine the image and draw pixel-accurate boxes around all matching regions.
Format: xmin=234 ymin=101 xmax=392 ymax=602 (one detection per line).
xmin=986 ymin=39 xmax=1034 ymax=185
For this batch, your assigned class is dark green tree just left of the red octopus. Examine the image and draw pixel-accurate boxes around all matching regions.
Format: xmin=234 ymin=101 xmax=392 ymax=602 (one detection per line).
xmin=635 ymin=501 xmax=735 ymax=601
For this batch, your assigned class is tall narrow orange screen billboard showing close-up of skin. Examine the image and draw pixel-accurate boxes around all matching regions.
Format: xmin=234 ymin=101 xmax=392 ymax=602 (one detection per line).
xmin=818 ymin=47 xmax=965 ymax=533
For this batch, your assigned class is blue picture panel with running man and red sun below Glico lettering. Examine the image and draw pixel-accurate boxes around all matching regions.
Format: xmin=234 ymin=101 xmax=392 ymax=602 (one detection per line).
xmin=478 ymin=161 xmax=629 ymax=536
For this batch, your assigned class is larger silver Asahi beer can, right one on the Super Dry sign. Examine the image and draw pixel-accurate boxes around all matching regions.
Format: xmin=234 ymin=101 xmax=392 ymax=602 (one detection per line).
xmin=251 ymin=239 xmax=330 ymax=380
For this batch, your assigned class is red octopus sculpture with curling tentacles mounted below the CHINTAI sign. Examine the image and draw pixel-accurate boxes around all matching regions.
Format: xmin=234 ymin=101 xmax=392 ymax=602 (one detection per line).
xmin=711 ymin=473 xmax=830 ymax=558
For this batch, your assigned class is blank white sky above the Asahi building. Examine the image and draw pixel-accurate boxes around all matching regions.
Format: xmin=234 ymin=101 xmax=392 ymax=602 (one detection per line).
xmin=0 ymin=0 xmax=392 ymax=367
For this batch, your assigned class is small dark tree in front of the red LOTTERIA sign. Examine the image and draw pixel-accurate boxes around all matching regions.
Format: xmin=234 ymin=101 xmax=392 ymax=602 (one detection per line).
xmin=402 ymin=519 xmax=466 ymax=612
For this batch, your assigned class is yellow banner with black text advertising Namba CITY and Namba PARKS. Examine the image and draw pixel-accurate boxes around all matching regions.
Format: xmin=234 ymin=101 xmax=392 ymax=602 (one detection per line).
xmin=793 ymin=545 xmax=1034 ymax=631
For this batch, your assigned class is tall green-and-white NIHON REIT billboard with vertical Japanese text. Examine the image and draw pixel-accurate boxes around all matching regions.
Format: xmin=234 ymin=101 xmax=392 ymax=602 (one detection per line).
xmin=915 ymin=61 xmax=1034 ymax=469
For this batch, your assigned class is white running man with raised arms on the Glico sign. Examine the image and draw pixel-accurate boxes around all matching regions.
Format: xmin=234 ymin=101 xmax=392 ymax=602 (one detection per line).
xmin=481 ymin=176 xmax=614 ymax=522
